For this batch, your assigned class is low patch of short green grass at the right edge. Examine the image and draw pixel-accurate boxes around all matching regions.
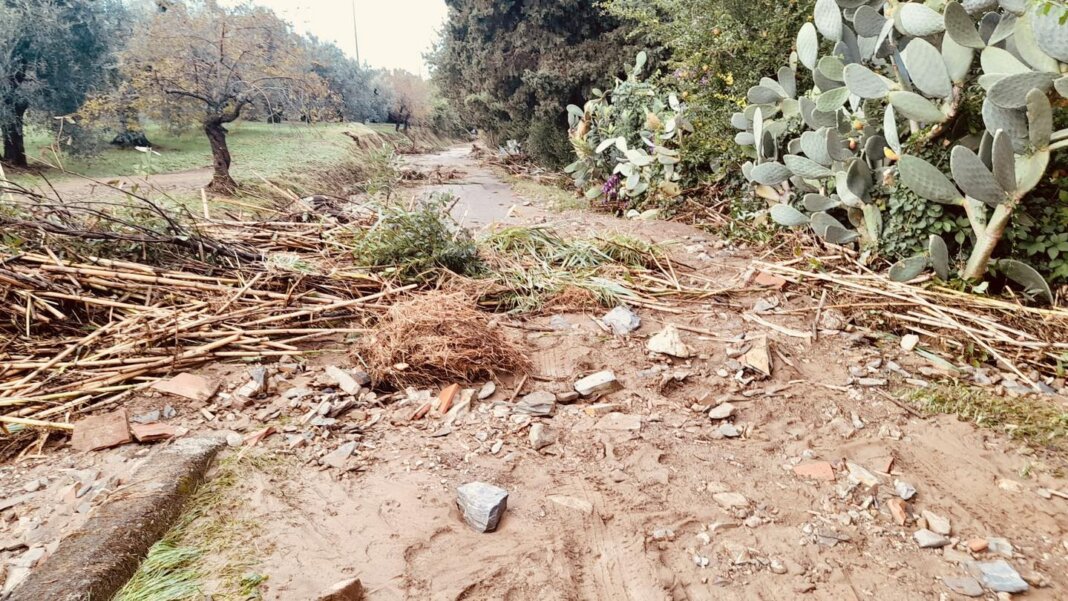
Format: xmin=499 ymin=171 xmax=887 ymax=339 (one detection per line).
xmin=908 ymin=384 xmax=1068 ymax=452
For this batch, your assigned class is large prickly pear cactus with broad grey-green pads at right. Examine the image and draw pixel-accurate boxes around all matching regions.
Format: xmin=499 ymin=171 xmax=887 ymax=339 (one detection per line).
xmin=732 ymin=0 xmax=1068 ymax=298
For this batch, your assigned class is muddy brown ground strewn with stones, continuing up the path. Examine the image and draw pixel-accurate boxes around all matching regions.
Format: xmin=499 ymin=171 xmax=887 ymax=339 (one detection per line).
xmin=0 ymin=147 xmax=1068 ymax=601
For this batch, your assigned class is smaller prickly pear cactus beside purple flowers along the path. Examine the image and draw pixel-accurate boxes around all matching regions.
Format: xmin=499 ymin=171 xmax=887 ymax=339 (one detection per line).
xmin=564 ymin=52 xmax=692 ymax=206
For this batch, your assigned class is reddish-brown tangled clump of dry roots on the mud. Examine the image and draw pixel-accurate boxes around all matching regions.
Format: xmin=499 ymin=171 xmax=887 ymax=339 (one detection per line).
xmin=357 ymin=292 xmax=531 ymax=390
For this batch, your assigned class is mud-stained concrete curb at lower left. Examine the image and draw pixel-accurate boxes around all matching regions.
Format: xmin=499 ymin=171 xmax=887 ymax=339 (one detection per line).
xmin=7 ymin=439 xmax=225 ymax=601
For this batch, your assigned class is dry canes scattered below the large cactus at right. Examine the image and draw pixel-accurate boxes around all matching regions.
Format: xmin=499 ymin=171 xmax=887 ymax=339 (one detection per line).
xmin=756 ymin=255 xmax=1068 ymax=390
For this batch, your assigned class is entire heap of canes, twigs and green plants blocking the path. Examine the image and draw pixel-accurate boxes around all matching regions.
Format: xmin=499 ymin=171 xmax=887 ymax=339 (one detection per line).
xmin=0 ymin=155 xmax=707 ymax=437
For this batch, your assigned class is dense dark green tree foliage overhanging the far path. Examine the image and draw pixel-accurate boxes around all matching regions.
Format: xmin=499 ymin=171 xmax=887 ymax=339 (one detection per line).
xmin=433 ymin=0 xmax=637 ymax=167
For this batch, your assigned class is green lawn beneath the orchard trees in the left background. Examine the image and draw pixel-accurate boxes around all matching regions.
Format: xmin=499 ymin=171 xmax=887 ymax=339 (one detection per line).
xmin=16 ymin=122 xmax=375 ymax=180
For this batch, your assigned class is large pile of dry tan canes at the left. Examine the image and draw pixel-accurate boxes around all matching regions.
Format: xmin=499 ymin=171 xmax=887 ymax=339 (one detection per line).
xmin=0 ymin=232 xmax=411 ymax=429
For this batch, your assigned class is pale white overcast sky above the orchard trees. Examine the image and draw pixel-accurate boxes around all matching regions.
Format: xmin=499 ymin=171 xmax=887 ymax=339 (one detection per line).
xmin=232 ymin=0 xmax=449 ymax=76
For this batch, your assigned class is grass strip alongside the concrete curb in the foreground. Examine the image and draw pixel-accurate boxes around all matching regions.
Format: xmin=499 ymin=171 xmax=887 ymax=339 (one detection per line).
xmin=114 ymin=454 xmax=287 ymax=601
